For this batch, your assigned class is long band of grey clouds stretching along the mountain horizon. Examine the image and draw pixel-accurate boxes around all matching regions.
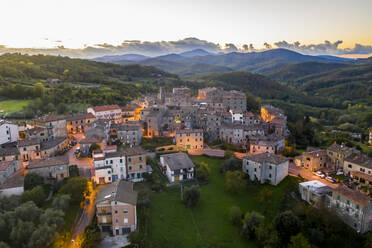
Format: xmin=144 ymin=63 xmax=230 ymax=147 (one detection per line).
xmin=0 ymin=37 xmax=372 ymax=58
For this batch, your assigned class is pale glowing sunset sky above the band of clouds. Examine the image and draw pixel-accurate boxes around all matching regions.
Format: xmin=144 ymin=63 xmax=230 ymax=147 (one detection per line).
xmin=0 ymin=0 xmax=372 ymax=52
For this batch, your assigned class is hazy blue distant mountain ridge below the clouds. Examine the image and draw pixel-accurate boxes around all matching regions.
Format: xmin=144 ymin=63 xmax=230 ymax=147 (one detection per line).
xmin=93 ymin=48 xmax=355 ymax=76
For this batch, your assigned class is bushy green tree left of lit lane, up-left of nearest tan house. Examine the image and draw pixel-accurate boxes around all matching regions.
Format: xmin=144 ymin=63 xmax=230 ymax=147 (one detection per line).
xmin=58 ymin=177 xmax=88 ymax=204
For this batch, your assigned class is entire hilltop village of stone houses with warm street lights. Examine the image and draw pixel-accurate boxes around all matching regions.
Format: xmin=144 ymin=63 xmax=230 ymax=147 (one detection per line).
xmin=0 ymin=87 xmax=372 ymax=247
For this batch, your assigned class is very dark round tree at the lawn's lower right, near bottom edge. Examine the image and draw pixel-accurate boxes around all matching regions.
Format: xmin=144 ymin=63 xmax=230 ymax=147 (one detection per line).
xmin=274 ymin=211 xmax=301 ymax=244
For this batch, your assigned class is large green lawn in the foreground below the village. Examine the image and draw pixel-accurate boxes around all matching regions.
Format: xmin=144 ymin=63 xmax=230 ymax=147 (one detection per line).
xmin=146 ymin=156 xmax=297 ymax=248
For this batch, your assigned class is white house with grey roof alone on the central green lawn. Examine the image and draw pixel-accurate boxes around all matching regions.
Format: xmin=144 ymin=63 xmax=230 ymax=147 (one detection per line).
xmin=160 ymin=152 xmax=195 ymax=183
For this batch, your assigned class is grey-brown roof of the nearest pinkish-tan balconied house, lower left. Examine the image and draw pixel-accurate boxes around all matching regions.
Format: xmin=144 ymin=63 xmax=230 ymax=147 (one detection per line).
xmin=95 ymin=180 xmax=138 ymax=205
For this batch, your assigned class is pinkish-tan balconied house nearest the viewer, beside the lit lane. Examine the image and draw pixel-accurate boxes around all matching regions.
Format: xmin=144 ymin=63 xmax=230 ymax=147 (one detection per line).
xmin=95 ymin=180 xmax=137 ymax=236
